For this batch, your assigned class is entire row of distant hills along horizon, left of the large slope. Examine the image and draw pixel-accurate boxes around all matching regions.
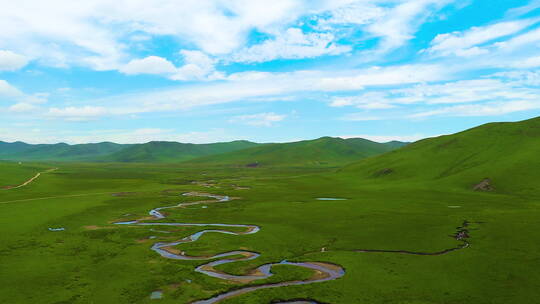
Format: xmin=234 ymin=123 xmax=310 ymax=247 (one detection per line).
xmin=0 ymin=137 xmax=407 ymax=166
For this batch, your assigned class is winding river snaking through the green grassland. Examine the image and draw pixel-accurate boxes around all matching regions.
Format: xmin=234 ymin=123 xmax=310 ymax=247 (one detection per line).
xmin=115 ymin=192 xmax=345 ymax=304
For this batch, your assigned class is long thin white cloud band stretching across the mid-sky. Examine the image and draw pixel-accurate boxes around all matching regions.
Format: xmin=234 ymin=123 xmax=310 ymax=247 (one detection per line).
xmin=54 ymin=65 xmax=452 ymax=115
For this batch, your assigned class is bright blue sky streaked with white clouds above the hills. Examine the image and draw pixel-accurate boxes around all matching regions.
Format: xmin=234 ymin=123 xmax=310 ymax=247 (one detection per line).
xmin=0 ymin=0 xmax=540 ymax=143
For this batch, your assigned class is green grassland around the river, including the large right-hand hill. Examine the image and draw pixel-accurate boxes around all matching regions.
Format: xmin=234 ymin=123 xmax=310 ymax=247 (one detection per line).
xmin=0 ymin=119 xmax=540 ymax=304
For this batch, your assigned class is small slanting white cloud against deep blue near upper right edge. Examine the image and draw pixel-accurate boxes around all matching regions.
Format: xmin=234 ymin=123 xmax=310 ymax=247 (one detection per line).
xmin=426 ymin=19 xmax=538 ymax=57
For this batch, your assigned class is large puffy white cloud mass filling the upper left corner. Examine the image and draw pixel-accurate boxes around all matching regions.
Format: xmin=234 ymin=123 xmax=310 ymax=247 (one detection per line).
xmin=0 ymin=0 xmax=307 ymax=70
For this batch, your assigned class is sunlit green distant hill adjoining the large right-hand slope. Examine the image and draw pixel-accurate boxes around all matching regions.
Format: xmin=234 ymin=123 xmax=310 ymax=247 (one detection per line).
xmin=187 ymin=137 xmax=404 ymax=166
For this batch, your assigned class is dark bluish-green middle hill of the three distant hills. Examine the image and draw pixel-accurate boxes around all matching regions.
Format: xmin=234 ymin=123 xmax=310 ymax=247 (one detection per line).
xmin=101 ymin=140 xmax=258 ymax=162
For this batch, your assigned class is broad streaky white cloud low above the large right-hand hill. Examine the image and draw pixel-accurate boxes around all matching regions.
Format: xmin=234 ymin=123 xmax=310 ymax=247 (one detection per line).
xmin=329 ymin=71 xmax=540 ymax=121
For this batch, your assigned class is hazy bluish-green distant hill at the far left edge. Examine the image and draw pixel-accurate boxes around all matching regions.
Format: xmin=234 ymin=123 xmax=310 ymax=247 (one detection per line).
xmin=0 ymin=142 xmax=126 ymax=161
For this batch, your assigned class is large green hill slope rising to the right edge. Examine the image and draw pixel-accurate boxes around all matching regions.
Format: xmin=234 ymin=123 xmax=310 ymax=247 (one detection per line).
xmin=341 ymin=117 xmax=540 ymax=193
